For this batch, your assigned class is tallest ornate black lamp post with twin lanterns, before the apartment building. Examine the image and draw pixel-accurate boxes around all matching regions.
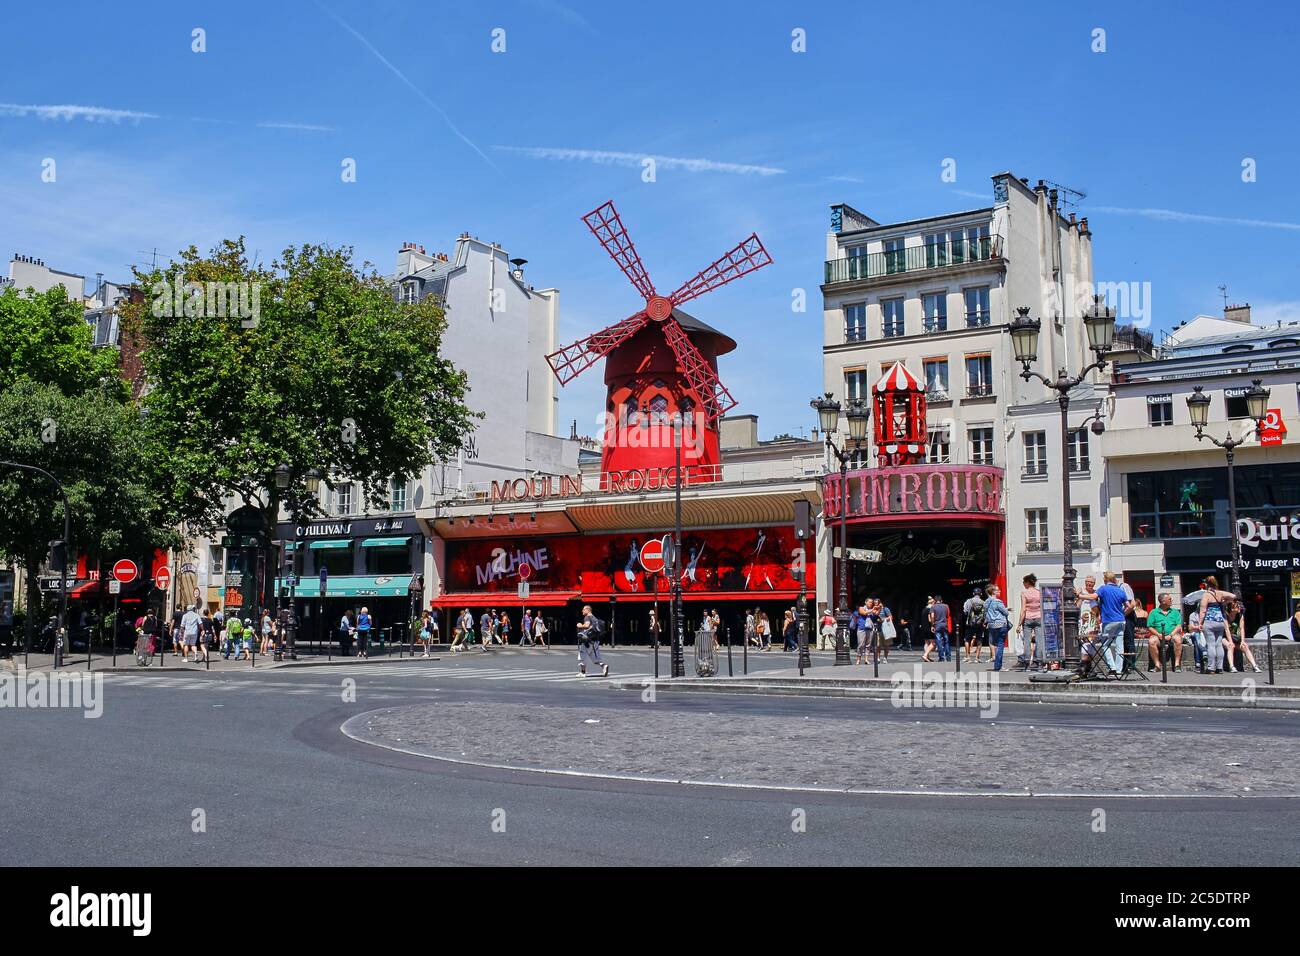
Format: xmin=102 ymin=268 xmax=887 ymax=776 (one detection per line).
xmin=1009 ymin=295 xmax=1115 ymax=661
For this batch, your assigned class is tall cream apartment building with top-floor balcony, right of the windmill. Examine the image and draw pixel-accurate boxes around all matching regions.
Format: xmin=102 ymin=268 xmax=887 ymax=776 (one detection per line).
xmin=819 ymin=172 xmax=1093 ymax=613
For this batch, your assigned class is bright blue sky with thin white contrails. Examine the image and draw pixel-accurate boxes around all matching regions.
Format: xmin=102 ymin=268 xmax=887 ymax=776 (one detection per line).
xmin=0 ymin=0 xmax=1300 ymax=437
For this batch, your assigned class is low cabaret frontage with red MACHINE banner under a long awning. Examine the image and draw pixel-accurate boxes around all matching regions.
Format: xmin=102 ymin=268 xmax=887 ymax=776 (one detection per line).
xmin=420 ymin=429 xmax=822 ymax=646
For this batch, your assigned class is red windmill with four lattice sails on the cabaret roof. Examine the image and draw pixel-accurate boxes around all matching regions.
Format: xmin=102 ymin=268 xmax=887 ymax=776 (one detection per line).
xmin=546 ymin=202 xmax=772 ymax=486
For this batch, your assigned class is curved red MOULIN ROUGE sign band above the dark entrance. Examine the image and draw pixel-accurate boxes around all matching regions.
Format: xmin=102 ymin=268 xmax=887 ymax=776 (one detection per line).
xmin=822 ymin=464 xmax=1004 ymax=519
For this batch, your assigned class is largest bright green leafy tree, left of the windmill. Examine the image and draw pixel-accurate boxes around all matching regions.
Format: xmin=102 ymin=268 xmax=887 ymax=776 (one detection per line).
xmin=124 ymin=238 xmax=475 ymax=533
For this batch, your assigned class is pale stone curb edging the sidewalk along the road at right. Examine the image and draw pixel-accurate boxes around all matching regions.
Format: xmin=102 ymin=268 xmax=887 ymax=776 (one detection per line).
xmin=608 ymin=678 xmax=1300 ymax=711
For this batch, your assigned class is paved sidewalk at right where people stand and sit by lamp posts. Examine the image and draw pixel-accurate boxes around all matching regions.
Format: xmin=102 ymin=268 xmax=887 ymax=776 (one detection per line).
xmin=612 ymin=643 xmax=1300 ymax=710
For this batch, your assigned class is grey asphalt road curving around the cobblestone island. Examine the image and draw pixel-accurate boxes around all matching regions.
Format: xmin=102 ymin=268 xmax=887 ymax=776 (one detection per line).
xmin=0 ymin=649 xmax=1300 ymax=866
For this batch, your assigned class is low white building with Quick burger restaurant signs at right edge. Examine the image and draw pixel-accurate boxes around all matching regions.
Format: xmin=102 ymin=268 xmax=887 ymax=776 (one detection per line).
xmin=1100 ymin=310 xmax=1300 ymax=632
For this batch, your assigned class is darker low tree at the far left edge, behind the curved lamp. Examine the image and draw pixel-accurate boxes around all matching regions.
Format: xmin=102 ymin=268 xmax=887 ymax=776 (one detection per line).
xmin=0 ymin=378 xmax=177 ymax=635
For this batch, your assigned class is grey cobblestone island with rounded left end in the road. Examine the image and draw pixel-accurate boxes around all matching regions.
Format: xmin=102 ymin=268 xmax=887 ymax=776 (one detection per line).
xmin=345 ymin=702 xmax=1300 ymax=796
